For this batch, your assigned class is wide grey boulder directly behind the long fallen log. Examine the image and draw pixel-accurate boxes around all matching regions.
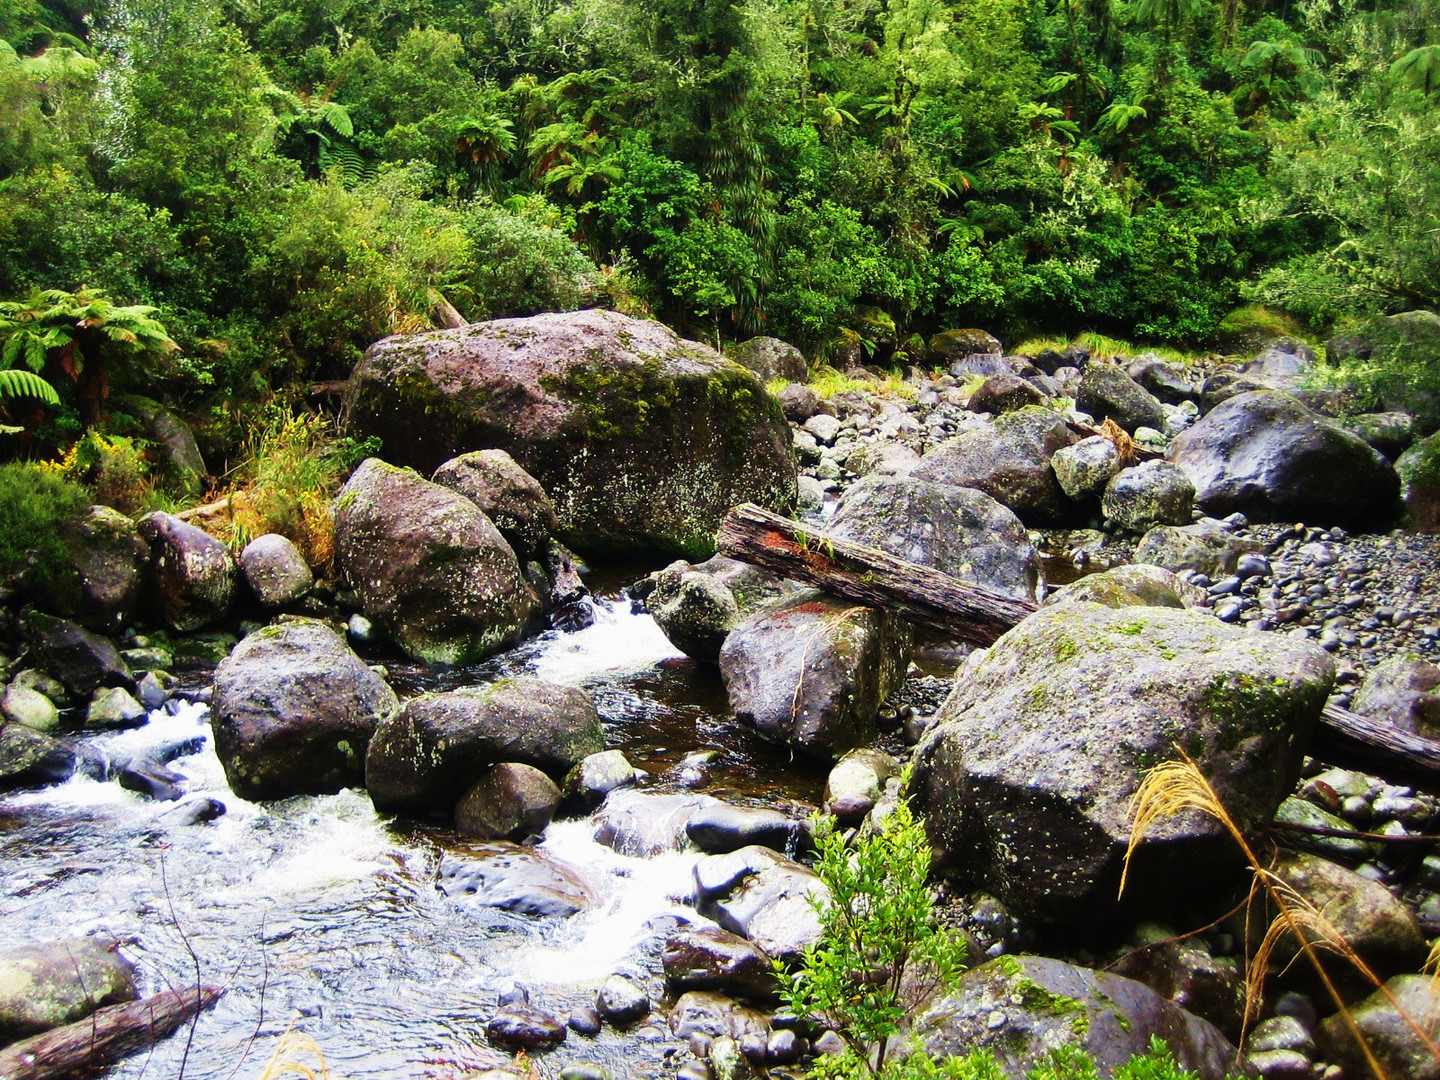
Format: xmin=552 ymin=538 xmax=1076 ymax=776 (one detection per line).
xmin=825 ymin=477 xmax=1040 ymax=600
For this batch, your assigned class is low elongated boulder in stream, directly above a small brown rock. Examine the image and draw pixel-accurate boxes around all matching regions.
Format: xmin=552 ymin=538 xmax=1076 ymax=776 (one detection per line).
xmin=366 ymin=678 xmax=605 ymax=811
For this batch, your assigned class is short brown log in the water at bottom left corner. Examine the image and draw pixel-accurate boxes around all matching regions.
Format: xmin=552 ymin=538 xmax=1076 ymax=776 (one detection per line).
xmin=0 ymin=986 xmax=225 ymax=1080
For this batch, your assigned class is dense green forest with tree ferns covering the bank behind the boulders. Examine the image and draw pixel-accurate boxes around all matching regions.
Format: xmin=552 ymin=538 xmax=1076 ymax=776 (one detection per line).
xmin=0 ymin=0 xmax=1440 ymax=426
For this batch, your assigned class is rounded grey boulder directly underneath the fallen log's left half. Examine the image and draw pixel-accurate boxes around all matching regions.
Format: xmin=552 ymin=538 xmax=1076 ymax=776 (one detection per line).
xmin=720 ymin=592 xmax=910 ymax=757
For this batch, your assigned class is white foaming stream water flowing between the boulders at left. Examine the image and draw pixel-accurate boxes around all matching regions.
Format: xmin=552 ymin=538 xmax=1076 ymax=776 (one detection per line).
xmin=0 ymin=600 xmax=822 ymax=1080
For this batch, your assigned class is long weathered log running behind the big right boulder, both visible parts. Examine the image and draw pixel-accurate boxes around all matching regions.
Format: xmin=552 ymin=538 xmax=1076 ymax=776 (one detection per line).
xmin=717 ymin=503 xmax=1440 ymax=791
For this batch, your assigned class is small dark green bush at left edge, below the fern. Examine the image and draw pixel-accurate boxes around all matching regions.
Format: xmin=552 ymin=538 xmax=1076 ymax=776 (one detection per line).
xmin=0 ymin=462 xmax=91 ymax=580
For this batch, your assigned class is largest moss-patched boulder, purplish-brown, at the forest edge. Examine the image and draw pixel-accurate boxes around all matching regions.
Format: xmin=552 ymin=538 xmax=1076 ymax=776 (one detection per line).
xmin=344 ymin=311 xmax=795 ymax=557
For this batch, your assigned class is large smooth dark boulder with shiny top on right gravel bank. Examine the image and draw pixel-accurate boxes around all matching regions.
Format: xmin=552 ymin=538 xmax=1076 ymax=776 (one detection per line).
xmin=1169 ymin=390 xmax=1400 ymax=527
